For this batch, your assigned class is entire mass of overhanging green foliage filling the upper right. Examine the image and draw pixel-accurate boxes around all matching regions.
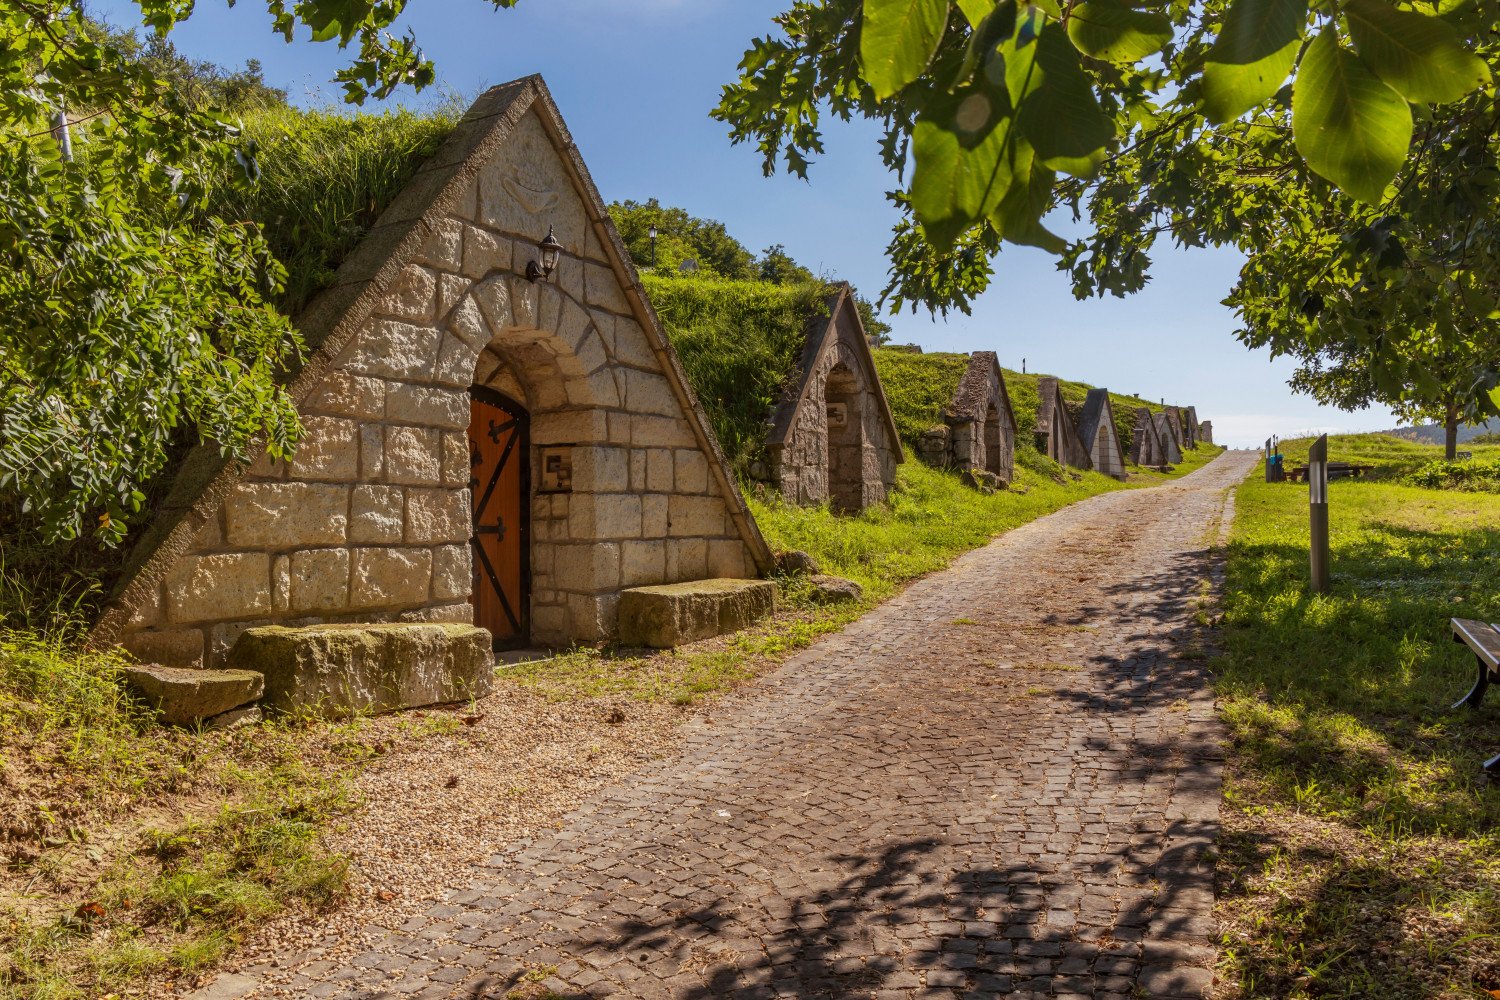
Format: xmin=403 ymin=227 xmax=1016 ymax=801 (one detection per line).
xmin=714 ymin=0 xmax=1496 ymax=393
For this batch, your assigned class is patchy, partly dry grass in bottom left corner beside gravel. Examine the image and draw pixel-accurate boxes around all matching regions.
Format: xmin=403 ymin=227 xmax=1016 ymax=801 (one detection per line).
xmin=0 ymin=631 xmax=393 ymax=1000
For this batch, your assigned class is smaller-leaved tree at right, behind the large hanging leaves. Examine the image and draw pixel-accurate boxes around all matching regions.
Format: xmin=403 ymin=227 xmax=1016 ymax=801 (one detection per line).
xmin=1064 ymin=0 xmax=1500 ymax=454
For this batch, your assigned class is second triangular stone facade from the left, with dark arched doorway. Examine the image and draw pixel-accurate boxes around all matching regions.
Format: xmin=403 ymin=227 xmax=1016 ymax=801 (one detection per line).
xmin=767 ymin=285 xmax=906 ymax=513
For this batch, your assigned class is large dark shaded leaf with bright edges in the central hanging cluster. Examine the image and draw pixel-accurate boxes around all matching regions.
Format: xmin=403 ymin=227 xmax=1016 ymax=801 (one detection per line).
xmin=1005 ymin=22 xmax=1115 ymax=177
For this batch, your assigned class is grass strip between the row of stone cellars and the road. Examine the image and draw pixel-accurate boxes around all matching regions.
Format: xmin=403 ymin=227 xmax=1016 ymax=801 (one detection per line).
xmin=501 ymin=448 xmax=1223 ymax=705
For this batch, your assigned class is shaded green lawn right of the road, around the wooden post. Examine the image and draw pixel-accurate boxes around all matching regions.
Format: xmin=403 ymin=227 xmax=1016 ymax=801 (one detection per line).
xmin=1214 ymin=435 xmax=1500 ymax=1000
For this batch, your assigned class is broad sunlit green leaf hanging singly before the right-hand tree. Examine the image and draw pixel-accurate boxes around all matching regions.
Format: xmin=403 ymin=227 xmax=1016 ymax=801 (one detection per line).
xmin=1292 ymin=24 xmax=1412 ymax=204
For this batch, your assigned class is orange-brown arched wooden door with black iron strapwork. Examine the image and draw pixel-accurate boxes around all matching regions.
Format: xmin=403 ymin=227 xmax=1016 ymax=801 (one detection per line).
xmin=470 ymin=385 xmax=531 ymax=649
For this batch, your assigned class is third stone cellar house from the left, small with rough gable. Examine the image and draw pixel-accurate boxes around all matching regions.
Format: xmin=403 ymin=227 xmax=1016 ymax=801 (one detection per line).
xmin=918 ymin=351 xmax=1017 ymax=486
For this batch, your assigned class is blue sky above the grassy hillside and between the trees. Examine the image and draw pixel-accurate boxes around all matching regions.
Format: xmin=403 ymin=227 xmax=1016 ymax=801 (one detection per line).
xmin=90 ymin=0 xmax=1397 ymax=445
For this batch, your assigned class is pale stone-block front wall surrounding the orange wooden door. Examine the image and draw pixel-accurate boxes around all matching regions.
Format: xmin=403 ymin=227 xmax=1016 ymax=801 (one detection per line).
xmin=109 ymin=89 xmax=758 ymax=664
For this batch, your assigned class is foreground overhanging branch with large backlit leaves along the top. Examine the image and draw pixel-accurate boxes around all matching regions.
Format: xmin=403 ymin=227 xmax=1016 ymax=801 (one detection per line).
xmin=714 ymin=0 xmax=1490 ymax=325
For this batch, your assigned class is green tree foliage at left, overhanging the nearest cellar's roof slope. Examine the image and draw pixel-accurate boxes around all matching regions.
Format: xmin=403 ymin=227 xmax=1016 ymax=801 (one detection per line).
xmin=0 ymin=0 xmax=512 ymax=543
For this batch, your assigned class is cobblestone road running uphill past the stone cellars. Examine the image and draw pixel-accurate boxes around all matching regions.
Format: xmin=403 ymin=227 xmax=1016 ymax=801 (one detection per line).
xmin=228 ymin=453 xmax=1254 ymax=1000
